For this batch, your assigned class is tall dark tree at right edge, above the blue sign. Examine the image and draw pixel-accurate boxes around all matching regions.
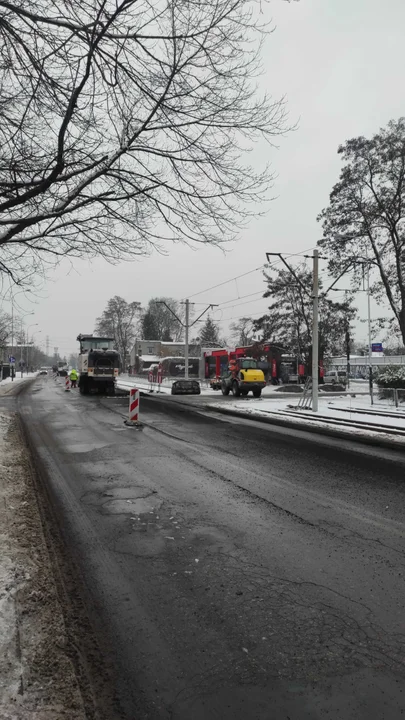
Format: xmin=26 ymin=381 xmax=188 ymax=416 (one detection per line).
xmin=318 ymin=118 xmax=405 ymax=343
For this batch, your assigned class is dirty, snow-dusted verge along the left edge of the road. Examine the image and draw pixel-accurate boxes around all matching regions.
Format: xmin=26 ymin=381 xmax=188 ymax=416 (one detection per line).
xmin=0 ymin=410 xmax=85 ymax=720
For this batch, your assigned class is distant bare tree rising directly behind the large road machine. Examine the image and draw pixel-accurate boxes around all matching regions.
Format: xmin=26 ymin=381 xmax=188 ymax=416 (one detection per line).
xmin=95 ymin=295 xmax=141 ymax=371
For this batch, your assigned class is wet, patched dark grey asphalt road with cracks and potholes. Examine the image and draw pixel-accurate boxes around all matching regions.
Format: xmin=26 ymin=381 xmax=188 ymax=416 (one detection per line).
xmin=14 ymin=378 xmax=405 ymax=720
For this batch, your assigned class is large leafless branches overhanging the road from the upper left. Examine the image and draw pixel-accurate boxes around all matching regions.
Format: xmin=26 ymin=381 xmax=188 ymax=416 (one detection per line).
xmin=0 ymin=0 xmax=286 ymax=283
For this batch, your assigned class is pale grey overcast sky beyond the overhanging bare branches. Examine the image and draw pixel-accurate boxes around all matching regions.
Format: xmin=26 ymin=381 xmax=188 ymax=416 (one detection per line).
xmin=11 ymin=0 xmax=405 ymax=355
